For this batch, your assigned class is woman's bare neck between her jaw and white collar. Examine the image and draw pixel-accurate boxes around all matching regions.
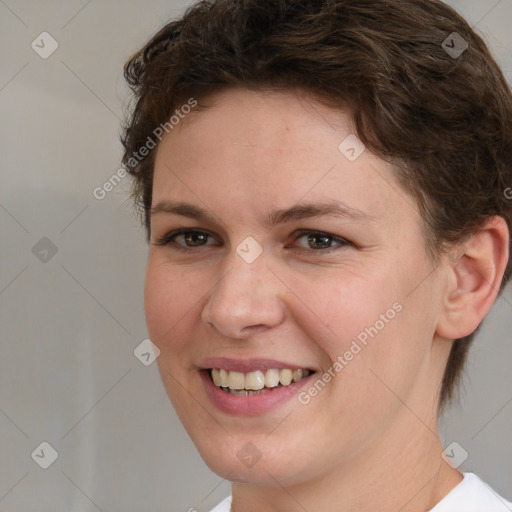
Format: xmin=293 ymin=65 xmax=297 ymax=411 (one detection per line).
xmin=232 ymin=409 xmax=462 ymax=512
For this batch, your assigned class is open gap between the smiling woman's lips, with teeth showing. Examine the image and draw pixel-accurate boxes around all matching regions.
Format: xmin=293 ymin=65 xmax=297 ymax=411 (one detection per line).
xmin=206 ymin=368 xmax=315 ymax=396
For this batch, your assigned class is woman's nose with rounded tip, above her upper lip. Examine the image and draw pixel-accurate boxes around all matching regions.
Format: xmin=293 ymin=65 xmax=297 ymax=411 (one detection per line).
xmin=201 ymin=254 xmax=285 ymax=339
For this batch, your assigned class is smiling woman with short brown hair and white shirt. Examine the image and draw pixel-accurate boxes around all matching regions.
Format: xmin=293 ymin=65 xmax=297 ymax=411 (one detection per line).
xmin=123 ymin=0 xmax=512 ymax=512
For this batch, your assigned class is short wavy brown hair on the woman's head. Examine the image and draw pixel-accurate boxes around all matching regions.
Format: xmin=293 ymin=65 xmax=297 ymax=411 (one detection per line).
xmin=122 ymin=0 xmax=512 ymax=407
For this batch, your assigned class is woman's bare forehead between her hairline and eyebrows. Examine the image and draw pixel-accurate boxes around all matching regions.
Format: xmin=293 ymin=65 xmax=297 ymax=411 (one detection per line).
xmin=153 ymin=89 xmax=418 ymax=231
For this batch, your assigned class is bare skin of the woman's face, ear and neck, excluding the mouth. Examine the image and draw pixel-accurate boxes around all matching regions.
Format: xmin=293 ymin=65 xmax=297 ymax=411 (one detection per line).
xmin=145 ymin=89 xmax=508 ymax=512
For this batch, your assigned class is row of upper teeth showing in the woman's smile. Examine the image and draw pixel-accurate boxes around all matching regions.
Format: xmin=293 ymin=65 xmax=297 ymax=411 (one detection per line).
xmin=211 ymin=368 xmax=311 ymax=395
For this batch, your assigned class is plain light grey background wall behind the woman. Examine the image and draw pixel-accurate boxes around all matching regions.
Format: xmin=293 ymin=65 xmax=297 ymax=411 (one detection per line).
xmin=0 ymin=0 xmax=512 ymax=512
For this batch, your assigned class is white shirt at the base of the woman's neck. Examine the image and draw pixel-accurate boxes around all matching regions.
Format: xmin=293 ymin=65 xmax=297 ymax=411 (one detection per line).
xmin=210 ymin=473 xmax=512 ymax=512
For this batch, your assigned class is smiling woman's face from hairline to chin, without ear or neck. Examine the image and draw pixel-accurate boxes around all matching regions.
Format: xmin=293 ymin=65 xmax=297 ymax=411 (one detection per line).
xmin=145 ymin=90 xmax=449 ymax=485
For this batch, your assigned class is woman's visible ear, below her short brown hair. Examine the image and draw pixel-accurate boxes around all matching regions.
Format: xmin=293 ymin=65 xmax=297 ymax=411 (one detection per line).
xmin=436 ymin=217 xmax=510 ymax=340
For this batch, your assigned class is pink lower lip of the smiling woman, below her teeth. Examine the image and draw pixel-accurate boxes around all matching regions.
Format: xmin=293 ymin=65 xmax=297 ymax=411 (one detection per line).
xmin=199 ymin=370 xmax=315 ymax=416
